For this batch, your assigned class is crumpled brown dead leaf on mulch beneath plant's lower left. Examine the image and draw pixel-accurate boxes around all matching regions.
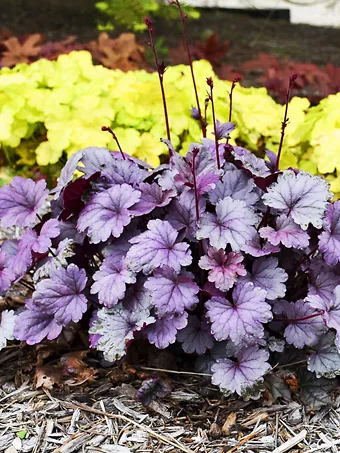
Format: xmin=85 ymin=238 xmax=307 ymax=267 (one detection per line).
xmin=61 ymin=351 xmax=97 ymax=385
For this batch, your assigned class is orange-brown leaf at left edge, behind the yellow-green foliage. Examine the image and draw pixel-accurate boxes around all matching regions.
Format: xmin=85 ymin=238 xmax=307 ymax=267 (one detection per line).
xmin=1 ymin=33 xmax=41 ymax=67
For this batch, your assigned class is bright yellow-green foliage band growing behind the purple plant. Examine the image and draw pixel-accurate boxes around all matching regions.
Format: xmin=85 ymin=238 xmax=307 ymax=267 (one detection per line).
xmin=0 ymin=51 xmax=340 ymax=192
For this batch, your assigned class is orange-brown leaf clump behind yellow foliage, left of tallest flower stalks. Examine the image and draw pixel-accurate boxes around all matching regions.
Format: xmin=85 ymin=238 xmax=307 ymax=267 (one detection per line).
xmin=88 ymin=32 xmax=146 ymax=71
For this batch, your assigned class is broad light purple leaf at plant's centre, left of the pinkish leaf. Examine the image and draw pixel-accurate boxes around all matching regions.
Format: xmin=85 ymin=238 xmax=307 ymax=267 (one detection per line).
xmin=126 ymin=219 xmax=192 ymax=274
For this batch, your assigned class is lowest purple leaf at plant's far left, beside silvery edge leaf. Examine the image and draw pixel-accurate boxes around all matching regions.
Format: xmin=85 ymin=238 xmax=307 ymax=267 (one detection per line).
xmin=14 ymin=301 xmax=63 ymax=345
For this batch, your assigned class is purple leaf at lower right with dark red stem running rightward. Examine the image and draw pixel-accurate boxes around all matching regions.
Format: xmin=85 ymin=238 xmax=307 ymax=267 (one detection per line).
xmin=274 ymin=300 xmax=326 ymax=349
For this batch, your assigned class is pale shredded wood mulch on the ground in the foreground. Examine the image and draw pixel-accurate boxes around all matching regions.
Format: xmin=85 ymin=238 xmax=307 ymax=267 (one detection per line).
xmin=0 ymin=345 xmax=340 ymax=453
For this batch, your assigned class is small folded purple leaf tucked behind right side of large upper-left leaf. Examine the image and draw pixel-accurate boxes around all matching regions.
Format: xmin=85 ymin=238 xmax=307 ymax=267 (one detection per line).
xmin=131 ymin=182 xmax=176 ymax=216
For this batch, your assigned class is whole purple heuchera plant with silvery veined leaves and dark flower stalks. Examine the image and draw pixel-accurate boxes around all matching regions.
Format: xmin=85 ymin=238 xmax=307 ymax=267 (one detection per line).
xmin=0 ymin=2 xmax=340 ymax=398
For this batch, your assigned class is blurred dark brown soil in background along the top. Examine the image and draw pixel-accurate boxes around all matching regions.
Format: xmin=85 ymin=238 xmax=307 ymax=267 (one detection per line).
xmin=0 ymin=0 xmax=340 ymax=66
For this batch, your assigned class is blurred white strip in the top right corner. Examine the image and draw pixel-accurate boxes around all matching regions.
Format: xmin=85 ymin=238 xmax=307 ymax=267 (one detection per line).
xmin=186 ymin=0 xmax=340 ymax=27
